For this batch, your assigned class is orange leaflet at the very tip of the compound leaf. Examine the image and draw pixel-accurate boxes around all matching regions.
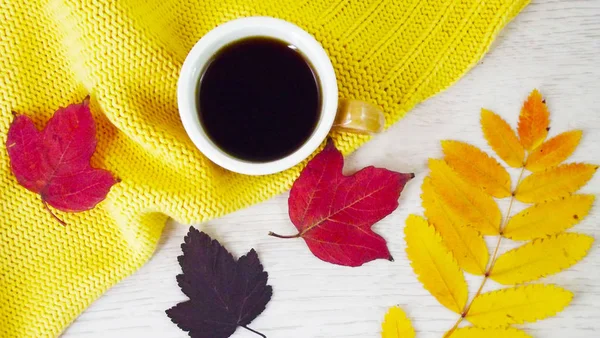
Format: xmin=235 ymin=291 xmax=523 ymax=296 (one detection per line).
xmin=517 ymin=89 xmax=550 ymax=150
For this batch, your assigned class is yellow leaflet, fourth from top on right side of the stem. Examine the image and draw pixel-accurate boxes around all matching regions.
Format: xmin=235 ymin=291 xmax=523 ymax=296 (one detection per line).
xmin=490 ymin=233 xmax=594 ymax=285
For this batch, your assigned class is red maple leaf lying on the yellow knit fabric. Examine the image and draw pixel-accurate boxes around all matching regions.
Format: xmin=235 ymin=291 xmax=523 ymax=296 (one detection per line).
xmin=6 ymin=97 xmax=117 ymax=224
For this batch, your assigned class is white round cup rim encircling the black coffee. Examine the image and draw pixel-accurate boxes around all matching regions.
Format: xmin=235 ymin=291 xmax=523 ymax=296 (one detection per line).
xmin=177 ymin=16 xmax=338 ymax=175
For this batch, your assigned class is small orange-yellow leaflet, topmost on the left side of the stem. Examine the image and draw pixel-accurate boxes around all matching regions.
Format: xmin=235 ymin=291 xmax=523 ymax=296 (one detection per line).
xmin=481 ymin=109 xmax=525 ymax=168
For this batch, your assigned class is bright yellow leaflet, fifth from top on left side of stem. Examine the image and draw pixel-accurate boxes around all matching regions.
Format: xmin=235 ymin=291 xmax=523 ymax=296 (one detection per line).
xmin=404 ymin=215 xmax=468 ymax=313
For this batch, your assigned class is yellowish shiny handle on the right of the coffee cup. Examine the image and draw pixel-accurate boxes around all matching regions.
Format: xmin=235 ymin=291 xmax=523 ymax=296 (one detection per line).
xmin=333 ymin=99 xmax=385 ymax=135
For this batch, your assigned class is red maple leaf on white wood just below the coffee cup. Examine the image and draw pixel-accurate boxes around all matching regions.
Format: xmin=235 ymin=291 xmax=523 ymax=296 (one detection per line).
xmin=270 ymin=140 xmax=415 ymax=266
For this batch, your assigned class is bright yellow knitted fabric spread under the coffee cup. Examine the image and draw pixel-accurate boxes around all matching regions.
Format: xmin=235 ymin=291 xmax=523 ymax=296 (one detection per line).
xmin=0 ymin=0 xmax=527 ymax=338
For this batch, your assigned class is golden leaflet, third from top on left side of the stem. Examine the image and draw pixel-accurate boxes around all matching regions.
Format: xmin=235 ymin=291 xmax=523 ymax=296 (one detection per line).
xmin=429 ymin=159 xmax=502 ymax=235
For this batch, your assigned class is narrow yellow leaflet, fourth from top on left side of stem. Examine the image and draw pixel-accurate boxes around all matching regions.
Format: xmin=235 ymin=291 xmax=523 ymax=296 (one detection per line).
xmin=421 ymin=177 xmax=489 ymax=275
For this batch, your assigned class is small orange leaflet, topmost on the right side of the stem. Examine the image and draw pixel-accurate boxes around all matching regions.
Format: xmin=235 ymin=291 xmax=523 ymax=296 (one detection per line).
xmin=525 ymin=130 xmax=582 ymax=171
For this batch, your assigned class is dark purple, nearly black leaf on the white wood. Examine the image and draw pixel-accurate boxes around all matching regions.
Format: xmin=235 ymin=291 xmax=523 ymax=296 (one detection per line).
xmin=166 ymin=227 xmax=273 ymax=338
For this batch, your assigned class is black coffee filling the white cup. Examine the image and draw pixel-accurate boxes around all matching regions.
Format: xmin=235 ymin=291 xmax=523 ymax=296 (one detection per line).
xmin=196 ymin=37 xmax=321 ymax=162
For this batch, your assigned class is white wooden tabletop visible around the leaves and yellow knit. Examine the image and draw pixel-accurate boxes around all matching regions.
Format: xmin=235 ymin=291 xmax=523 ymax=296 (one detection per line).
xmin=63 ymin=0 xmax=600 ymax=338
